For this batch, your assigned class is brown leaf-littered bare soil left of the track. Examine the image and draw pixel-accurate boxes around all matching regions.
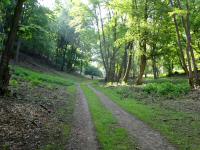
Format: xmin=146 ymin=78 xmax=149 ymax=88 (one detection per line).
xmin=0 ymin=81 xmax=71 ymax=150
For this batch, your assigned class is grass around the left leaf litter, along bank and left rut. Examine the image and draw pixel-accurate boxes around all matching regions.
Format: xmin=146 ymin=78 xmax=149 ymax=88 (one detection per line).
xmin=10 ymin=66 xmax=79 ymax=150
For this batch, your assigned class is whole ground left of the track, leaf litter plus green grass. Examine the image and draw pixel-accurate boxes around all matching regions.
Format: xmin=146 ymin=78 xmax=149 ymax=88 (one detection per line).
xmin=0 ymin=66 xmax=76 ymax=150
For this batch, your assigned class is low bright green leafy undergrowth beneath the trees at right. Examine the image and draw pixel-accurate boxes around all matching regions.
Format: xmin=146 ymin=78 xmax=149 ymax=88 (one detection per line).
xmin=144 ymin=82 xmax=190 ymax=96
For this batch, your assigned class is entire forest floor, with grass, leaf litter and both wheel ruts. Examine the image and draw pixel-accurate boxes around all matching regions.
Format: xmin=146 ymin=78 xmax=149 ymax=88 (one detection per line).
xmin=0 ymin=65 xmax=200 ymax=150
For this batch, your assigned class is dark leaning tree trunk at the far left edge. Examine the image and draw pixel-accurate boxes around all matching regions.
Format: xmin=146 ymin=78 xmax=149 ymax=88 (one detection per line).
xmin=0 ymin=0 xmax=24 ymax=95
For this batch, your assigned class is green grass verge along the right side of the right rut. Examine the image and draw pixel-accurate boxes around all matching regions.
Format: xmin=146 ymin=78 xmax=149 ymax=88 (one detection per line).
xmin=95 ymin=85 xmax=200 ymax=150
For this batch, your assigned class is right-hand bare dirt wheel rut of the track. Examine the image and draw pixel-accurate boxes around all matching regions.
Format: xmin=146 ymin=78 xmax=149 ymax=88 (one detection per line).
xmin=88 ymin=85 xmax=175 ymax=150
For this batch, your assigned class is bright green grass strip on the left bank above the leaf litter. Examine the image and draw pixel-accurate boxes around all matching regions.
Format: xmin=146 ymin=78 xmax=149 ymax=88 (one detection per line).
xmin=11 ymin=66 xmax=74 ymax=86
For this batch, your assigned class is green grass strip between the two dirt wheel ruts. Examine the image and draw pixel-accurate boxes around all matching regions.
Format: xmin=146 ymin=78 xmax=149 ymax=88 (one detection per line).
xmin=81 ymin=85 xmax=136 ymax=150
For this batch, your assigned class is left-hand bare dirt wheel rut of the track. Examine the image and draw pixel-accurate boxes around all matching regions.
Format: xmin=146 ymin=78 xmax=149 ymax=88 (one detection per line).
xmin=67 ymin=86 xmax=99 ymax=150
